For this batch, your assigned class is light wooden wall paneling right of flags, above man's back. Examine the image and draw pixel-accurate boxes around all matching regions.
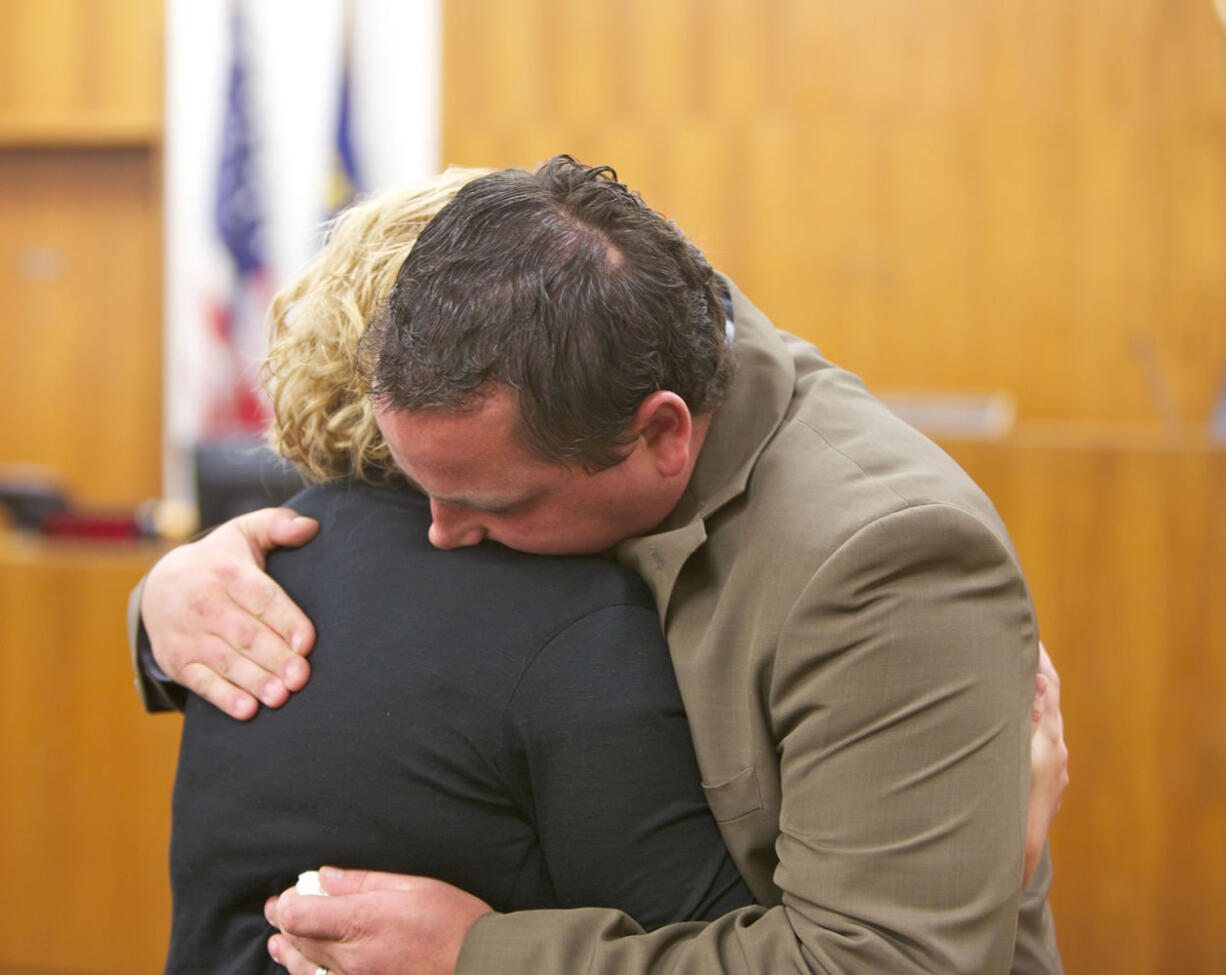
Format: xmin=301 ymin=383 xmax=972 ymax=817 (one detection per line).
xmin=444 ymin=0 xmax=1226 ymax=426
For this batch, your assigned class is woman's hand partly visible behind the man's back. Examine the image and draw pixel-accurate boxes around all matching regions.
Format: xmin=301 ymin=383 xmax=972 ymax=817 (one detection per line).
xmin=1021 ymin=644 xmax=1069 ymax=887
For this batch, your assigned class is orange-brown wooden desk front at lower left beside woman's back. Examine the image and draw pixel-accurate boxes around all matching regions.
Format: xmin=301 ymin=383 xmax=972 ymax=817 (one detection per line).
xmin=0 ymin=535 xmax=180 ymax=975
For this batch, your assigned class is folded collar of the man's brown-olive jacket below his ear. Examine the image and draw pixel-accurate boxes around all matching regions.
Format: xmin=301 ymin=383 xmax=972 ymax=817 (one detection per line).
xmin=615 ymin=278 xmax=796 ymax=619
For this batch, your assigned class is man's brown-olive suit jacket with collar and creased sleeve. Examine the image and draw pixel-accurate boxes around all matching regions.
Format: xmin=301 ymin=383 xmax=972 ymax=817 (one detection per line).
xmin=457 ymin=275 xmax=1062 ymax=975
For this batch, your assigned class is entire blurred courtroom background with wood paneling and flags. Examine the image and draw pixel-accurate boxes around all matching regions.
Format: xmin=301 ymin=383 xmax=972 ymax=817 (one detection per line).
xmin=0 ymin=0 xmax=1226 ymax=975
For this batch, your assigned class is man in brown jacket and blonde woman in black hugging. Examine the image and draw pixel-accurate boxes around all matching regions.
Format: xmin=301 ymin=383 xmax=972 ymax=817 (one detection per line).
xmin=130 ymin=157 xmax=1067 ymax=975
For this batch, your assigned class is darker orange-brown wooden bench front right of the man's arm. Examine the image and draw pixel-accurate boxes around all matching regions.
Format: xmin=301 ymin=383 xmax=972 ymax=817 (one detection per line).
xmin=946 ymin=429 xmax=1226 ymax=975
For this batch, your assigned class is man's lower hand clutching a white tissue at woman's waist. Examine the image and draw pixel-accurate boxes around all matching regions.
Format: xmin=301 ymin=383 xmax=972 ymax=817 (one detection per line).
xmin=264 ymin=867 xmax=492 ymax=975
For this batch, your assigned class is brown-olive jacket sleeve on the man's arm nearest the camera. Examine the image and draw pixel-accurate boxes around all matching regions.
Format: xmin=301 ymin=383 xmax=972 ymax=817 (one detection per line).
xmin=457 ymin=505 xmax=1059 ymax=975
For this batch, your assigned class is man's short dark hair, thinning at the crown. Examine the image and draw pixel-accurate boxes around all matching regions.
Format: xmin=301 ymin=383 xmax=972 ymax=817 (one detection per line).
xmin=360 ymin=156 xmax=732 ymax=471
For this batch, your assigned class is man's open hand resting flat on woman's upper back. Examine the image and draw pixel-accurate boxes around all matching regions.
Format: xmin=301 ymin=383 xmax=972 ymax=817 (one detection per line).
xmin=140 ymin=508 xmax=319 ymax=721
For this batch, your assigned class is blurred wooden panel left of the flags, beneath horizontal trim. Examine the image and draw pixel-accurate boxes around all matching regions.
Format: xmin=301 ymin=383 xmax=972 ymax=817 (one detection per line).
xmin=0 ymin=148 xmax=162 ymax=505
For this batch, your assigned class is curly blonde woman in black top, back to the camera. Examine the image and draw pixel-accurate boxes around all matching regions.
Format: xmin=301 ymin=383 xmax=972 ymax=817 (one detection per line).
xmin=160 ymin=170 xmax=752 ymax=973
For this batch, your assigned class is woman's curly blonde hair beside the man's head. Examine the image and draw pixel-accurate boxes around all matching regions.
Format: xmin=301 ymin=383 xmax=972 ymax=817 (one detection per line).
xmin=260 ymin=167 xmax=488 ymax=482
